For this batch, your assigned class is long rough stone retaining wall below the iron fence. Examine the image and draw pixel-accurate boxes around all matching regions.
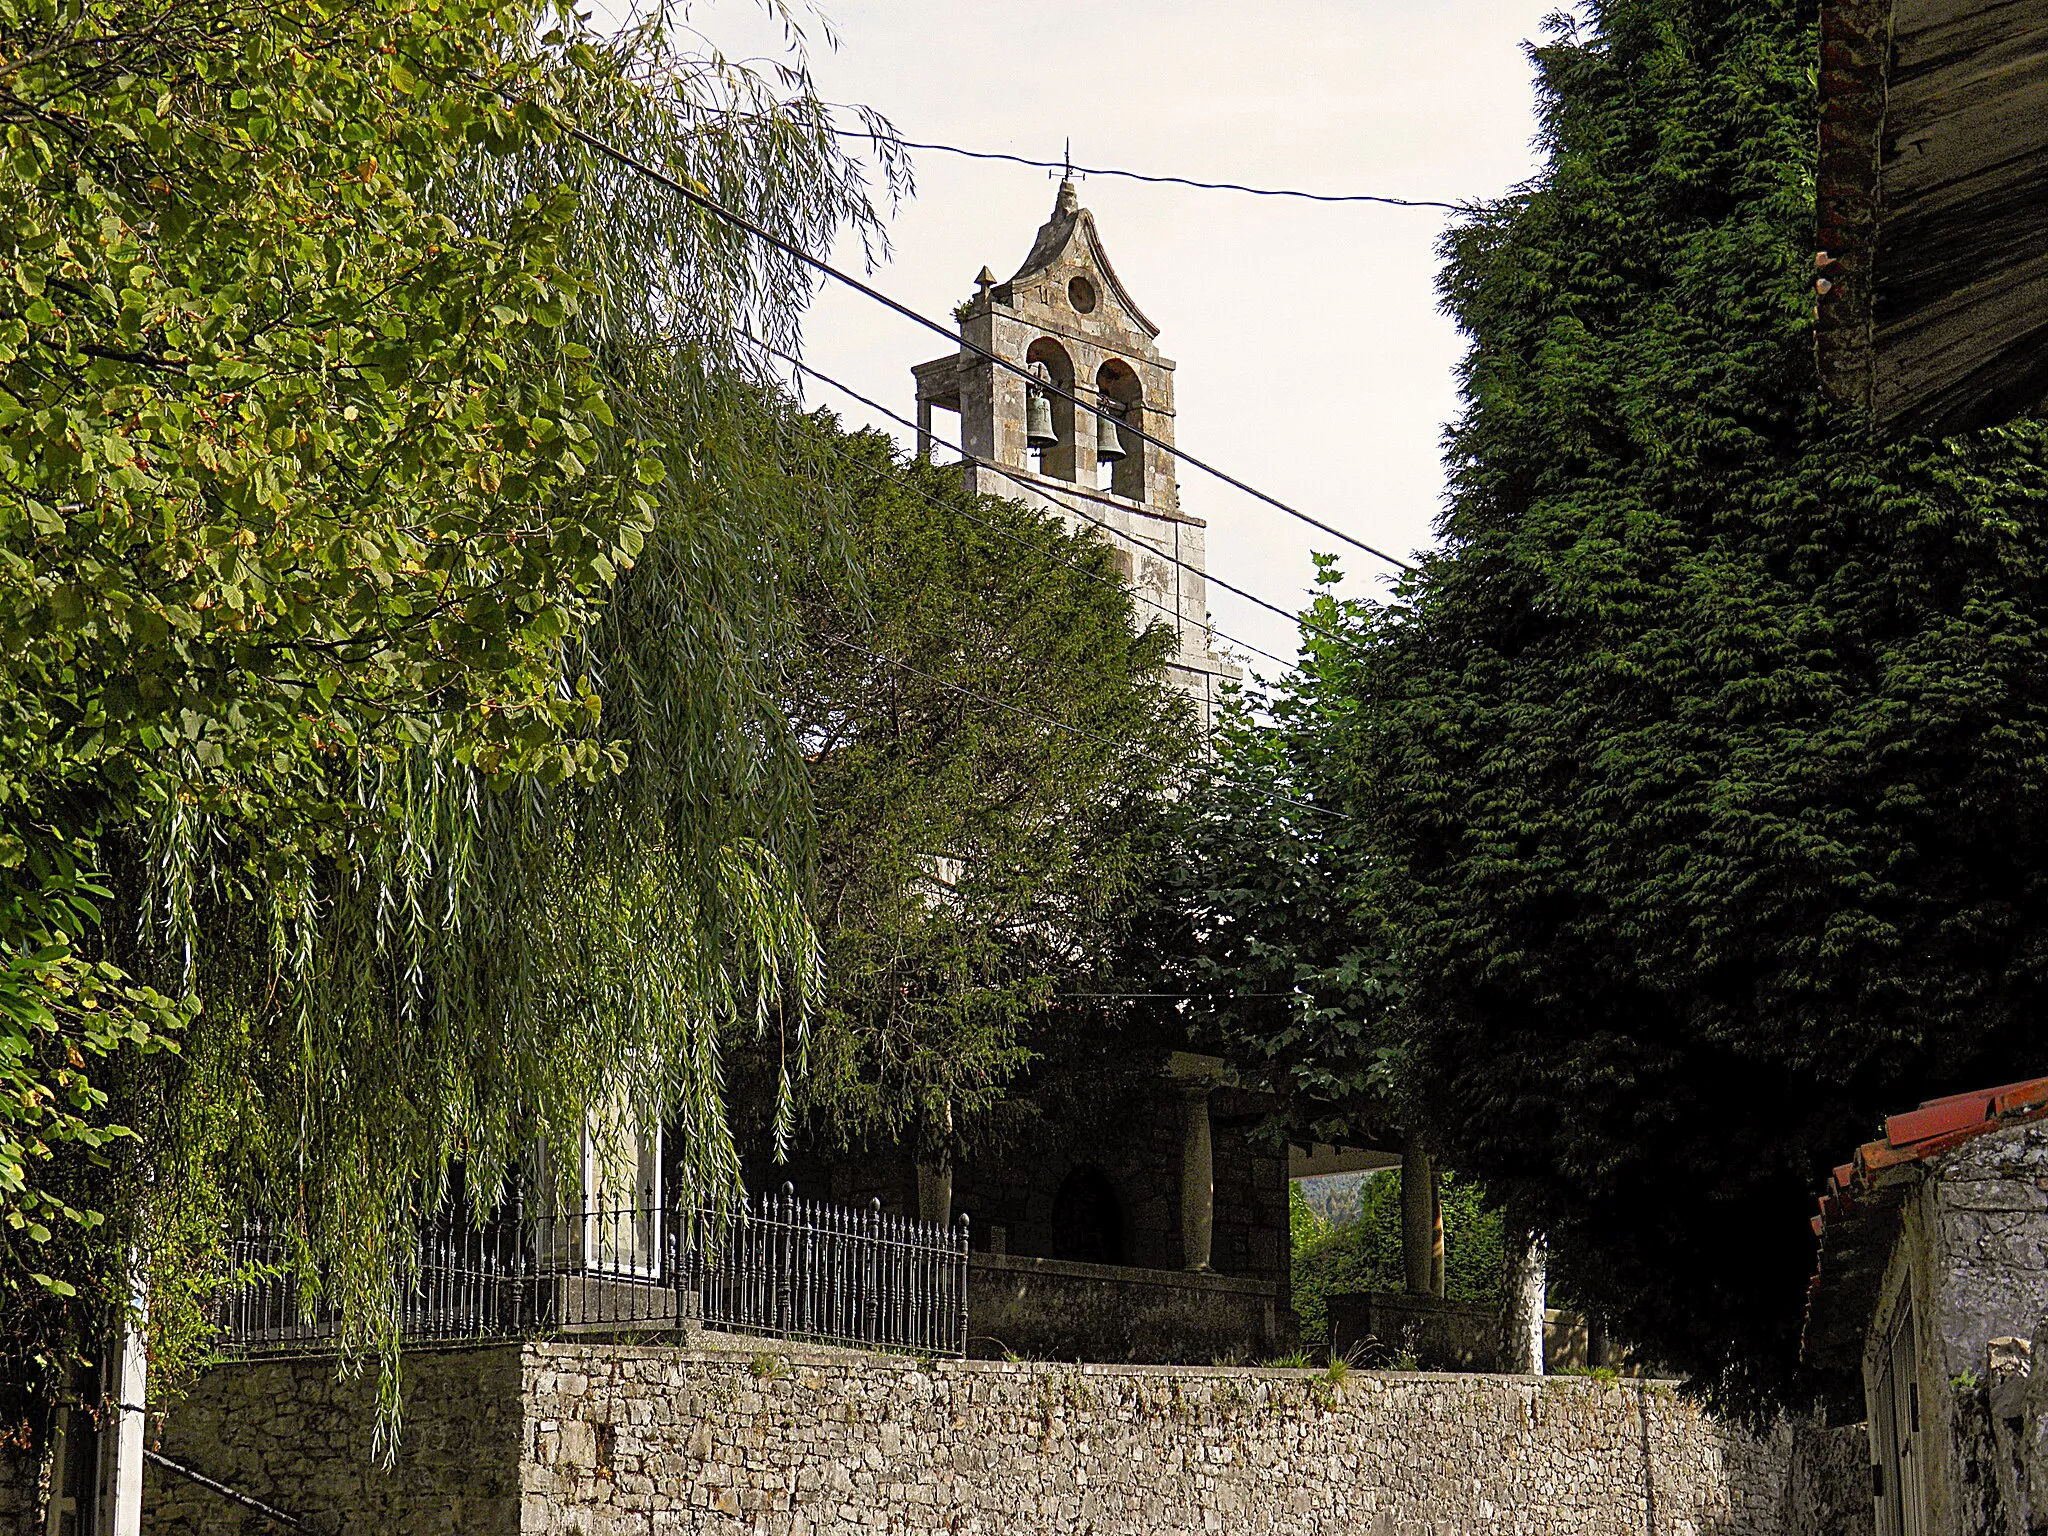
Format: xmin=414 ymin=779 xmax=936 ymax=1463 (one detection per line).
xmin=123 ymin=1341 xmax=1868 ymax=1536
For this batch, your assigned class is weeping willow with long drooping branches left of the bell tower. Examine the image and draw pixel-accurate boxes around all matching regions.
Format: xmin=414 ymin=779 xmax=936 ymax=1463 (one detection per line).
xmin=0 ymin=6 xmax=907 ymax=1448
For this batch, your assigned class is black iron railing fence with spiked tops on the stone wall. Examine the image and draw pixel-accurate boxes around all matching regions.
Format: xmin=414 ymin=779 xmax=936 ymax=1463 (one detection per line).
xmin=217 ymin=1186 xmax=967 ymax=1356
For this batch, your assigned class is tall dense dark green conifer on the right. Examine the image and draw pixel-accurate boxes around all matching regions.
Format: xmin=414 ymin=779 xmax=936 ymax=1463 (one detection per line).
xmin=1303 ymin=0 xmax=2048 ymax=1405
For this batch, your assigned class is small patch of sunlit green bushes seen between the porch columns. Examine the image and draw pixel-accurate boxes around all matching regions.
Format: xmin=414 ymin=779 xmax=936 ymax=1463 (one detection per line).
xmin=1288 ymin=1174 xmax=1503 ymax=1348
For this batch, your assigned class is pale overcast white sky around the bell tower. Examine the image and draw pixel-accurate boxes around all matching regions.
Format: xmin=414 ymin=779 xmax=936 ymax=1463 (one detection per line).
xmin=692 ymin=0 xmax=1559 ymax=672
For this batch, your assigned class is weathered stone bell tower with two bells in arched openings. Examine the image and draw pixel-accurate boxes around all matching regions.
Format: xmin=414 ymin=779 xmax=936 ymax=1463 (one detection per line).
xmin=911 ymin=180 xmax=1243 ymax=725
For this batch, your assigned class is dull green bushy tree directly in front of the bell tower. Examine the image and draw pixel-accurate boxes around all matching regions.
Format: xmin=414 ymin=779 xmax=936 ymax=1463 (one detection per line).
xmin=761 ymin=416 xmax=1196 ymax=1145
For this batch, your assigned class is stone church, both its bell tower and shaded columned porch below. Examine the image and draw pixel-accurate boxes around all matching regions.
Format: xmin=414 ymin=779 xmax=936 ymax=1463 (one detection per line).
xmin=762 ymin=182 xmax=1294 ymax=1364
